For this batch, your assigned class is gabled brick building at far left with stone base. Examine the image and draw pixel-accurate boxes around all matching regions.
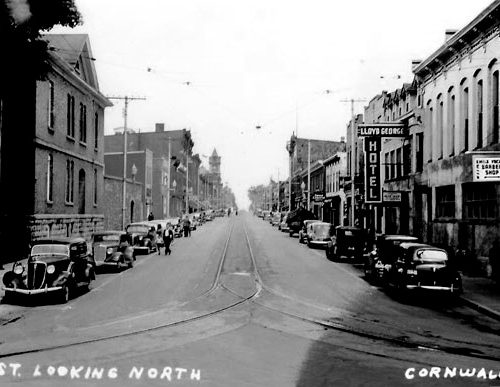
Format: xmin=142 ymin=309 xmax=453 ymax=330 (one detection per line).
xmin=0 ymin=34 xmax=111 ymax=260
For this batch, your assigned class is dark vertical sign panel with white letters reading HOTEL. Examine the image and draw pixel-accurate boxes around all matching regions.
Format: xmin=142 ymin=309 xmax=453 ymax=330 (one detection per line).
xmin=365 ymin=137 xmax=382 ymax=203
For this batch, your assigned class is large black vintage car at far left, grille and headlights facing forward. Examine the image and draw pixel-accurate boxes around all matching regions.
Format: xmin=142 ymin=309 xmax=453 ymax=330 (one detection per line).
xmin=3 ymin=238 xmax=95 ymax=303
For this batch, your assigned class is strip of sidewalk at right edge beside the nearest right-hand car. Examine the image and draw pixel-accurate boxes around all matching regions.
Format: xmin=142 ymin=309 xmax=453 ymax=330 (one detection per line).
xmin=461 ymin=275 xmax=500 ymax=321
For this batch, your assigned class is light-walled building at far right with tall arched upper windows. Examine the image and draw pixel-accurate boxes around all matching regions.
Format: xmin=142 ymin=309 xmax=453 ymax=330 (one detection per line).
xmin=414 ymin=0 xmax=500 ymax=257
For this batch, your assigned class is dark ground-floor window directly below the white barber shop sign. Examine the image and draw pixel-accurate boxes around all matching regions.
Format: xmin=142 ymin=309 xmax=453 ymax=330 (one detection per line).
xmin=462 ymin=183 xmax=497 ymax=219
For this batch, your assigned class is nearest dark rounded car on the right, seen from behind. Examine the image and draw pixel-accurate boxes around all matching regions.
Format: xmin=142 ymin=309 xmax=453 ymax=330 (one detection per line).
xmin=376 ymin=242 xmax=462 ymax=295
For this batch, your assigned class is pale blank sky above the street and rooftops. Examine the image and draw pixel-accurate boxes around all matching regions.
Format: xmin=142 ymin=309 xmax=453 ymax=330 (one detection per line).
xmin=49 ymin=0 xmax=492 ymax=208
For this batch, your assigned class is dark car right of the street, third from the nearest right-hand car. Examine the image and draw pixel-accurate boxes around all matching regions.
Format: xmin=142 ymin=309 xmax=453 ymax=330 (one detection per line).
xmin=326 ymin=226 xmax=371 ymax=261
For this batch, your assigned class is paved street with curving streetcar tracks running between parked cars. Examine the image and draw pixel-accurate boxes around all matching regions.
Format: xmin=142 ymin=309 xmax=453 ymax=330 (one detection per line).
xmin=0 ymin=213 xmax=500 ymax=386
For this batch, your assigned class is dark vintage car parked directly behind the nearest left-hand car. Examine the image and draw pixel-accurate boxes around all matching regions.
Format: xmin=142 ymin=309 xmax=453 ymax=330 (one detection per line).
xmin=91 ymin=230 xmax=135 ymax=270
